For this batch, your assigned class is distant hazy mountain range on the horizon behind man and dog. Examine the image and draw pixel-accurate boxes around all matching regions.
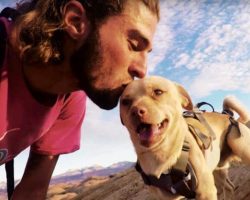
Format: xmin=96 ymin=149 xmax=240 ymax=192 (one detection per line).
xmin=50 ymin=162 xmax=134 ymax=185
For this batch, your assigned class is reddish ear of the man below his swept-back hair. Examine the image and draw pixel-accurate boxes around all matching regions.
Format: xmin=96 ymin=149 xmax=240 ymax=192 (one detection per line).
xmin=62 ymin=0 xmax=90 ymax=40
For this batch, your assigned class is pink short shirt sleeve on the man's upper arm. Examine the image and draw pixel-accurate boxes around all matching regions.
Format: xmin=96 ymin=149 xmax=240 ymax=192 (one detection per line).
xmin=31 ymin=91 xmax=86 ymax=155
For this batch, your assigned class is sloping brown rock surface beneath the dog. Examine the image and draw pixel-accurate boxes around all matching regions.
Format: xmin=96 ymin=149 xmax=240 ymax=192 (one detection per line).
xmin=47 ymin=165 xmax=250 ymax=200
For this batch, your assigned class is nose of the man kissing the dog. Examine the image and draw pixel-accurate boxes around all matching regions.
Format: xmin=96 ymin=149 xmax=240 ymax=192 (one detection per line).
xmin=128 ymin=53 xmax=147 ymax=78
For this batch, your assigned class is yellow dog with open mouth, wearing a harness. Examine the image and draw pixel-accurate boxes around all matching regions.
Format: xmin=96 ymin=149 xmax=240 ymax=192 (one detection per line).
xmin=120 ymin=76 xmax=250 ymax=200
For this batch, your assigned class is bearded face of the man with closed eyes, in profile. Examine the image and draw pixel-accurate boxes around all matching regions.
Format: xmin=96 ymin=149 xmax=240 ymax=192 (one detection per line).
xmin=72 ymin=1 xmax=157 ymax=109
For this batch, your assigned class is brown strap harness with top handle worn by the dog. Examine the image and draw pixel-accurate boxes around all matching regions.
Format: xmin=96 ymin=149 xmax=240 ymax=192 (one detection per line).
xmin=135 ymin=102 xmax=240 ymax=199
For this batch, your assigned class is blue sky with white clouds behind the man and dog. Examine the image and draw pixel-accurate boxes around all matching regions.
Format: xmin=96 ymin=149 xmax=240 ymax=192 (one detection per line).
xmin=0 ymin=0 xmax=250 ymax=180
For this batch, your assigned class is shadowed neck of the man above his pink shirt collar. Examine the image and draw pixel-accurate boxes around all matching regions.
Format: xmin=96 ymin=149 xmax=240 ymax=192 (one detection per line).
xmin=23 ymin=63 xmax=79 ymax=106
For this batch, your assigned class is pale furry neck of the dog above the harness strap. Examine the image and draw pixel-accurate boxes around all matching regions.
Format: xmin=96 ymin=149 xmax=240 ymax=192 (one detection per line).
xmin=138 ymin=118 xmax=188 ymax=178
